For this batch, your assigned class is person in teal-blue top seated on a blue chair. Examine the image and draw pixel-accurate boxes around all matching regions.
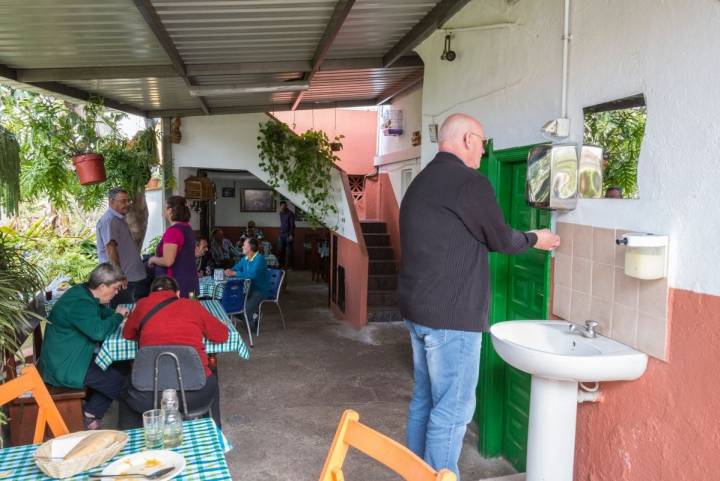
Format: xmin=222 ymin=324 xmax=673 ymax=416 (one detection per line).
xmin=225 ymin=238 xmax=271 ymax=331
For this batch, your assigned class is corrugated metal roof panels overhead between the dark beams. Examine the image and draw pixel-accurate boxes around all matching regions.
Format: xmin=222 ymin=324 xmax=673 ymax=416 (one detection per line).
xmin=0 ymin=0 xmax=448 ymax=112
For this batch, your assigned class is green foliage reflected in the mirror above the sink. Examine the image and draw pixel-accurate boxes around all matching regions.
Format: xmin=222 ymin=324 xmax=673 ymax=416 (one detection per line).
xmin=584 ymin=107 xmax=647 ymax=199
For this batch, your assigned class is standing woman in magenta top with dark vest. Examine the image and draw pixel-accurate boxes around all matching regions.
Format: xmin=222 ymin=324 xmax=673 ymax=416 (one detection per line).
xmin=148 ymin=195 xmax=200 ymax=297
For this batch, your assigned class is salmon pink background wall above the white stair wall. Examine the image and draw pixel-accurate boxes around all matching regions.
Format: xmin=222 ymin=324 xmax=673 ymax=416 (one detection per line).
xmin=274 ymin=109 xmax=377 ymax=175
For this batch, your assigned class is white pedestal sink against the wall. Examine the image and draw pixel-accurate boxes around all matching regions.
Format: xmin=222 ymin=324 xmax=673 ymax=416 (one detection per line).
xmin=490 ymin=321 xmax=647 ymax=481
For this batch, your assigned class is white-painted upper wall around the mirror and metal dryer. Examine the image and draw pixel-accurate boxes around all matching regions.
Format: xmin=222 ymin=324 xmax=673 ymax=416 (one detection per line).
xmin=418 ymin=0 xmax=720 ymax=295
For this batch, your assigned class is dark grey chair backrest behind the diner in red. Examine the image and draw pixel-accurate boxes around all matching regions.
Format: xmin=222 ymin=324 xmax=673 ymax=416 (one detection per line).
xmin=131 ymin=345 xmax=207 ymax=392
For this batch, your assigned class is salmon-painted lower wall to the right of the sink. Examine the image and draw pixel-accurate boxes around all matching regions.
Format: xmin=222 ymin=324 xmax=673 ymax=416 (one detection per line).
xmin=575 ymin=289 xmax=720 ymax=481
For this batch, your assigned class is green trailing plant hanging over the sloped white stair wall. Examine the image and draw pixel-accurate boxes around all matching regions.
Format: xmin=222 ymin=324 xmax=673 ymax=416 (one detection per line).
xmin=258 ymin=120 xmax=342 ymax=227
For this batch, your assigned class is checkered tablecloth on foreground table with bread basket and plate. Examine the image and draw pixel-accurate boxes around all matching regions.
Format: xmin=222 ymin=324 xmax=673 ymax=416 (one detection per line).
xmin=0 ymin=418 xmax=232 ymax=481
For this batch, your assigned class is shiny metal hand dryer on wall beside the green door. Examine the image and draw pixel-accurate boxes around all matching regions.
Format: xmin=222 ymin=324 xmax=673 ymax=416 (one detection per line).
xmin=526 ymin=144 xmax=578 ymax=210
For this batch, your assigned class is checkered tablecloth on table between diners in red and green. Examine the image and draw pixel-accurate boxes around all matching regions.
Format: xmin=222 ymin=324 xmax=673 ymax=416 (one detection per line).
xmin=95 ymin=301 xmax=250 ymax=370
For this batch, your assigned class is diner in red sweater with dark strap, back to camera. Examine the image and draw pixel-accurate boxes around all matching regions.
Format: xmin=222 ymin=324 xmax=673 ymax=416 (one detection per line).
xmin=121 ymin=276 xmax=228 ymax=429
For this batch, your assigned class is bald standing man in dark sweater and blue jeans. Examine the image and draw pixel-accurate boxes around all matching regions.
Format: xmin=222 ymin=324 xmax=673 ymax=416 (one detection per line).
xmin=398 ymin=114 xmax=560 ymax=479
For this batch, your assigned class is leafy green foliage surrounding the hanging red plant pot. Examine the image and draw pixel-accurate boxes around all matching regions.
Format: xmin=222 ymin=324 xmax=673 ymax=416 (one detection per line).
xmin=0 ymin=87 xmax=159 ymax=210
